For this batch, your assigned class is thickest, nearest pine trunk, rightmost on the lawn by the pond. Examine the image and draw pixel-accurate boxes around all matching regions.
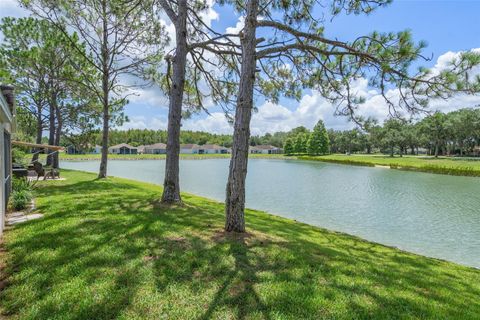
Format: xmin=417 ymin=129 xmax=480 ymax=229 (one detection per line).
xmin=225 ymin=0 xmax=258 ymax=232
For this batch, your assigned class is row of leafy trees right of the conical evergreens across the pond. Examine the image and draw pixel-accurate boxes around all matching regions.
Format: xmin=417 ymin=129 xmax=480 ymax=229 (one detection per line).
xmin=328 ymin=109 xmax=480 ymax=157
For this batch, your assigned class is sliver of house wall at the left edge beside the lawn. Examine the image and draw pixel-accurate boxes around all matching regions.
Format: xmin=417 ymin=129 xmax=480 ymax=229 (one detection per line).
xmin=0 ymin=85 xmax=15 ymax=235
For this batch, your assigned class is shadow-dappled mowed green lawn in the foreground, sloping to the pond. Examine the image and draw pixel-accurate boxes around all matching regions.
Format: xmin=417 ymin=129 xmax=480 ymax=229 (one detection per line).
xmin=0 ymin=171 xmax=480 ymax=319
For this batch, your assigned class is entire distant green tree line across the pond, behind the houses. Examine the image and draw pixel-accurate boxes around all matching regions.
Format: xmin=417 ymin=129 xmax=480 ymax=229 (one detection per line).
xmin=61 ymin=108 xmax=480 ymax=156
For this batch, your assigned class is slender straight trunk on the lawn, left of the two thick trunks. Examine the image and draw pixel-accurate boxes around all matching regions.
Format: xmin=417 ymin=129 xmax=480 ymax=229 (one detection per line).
xmin=98 ymin=0 xmax=110 ymax=179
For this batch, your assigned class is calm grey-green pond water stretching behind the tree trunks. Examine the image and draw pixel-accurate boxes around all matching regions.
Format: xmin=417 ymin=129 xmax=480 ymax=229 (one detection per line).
xmin=62 ymin=159 xmax=480 ymax=267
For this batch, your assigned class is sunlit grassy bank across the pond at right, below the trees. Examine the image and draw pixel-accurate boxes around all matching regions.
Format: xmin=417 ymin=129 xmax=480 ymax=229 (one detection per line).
xmin=298 ymin=154 xmax=480 ymax=177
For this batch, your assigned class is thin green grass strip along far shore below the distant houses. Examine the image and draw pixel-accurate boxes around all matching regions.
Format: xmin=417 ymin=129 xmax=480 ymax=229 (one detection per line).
xmin=56 ymin=153 xmax=290 ymax=161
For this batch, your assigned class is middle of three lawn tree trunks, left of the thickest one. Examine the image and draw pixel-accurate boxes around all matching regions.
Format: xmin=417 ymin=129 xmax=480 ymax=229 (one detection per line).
xmin=162 ymin=0 xmax=188 ymax=204
